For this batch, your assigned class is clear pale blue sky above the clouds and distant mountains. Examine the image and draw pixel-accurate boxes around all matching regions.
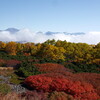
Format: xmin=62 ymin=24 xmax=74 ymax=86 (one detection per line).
xmin=0 ymin=0 xmax=100 ymax=32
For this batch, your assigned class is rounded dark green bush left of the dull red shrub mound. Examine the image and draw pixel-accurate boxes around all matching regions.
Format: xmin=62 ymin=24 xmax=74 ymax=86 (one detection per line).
xmin=17 ymin=61 xmax=41 ymax=77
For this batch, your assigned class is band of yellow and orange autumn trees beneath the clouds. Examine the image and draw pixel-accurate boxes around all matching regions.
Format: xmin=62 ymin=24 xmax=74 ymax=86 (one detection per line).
xmin=0 ymin=39 xmax=100 ymax=64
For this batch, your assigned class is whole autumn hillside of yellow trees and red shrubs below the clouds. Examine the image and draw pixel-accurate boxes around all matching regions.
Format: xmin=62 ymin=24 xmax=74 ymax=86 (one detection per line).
xmin=0 ymin=40 xmax=100 ymax=100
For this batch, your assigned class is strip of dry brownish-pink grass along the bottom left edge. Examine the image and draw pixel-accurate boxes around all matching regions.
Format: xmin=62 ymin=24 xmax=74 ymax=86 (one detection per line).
xmin=0 ymin=91 xmax=48 ymax=100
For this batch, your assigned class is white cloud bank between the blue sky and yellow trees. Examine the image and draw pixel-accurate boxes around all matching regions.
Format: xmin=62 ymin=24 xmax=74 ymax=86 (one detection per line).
xmin=0 ymin=29 xmax=100 ymax=44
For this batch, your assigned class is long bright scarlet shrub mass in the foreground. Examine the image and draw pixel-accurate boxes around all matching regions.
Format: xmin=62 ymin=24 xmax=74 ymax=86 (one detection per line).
xmin=25 ymin=74 xmax=99 ymax=100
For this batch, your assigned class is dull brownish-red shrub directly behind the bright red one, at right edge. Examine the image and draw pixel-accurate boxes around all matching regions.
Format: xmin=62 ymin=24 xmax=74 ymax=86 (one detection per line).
xmin=50 ymin=71 xmax=100 ymax=95
